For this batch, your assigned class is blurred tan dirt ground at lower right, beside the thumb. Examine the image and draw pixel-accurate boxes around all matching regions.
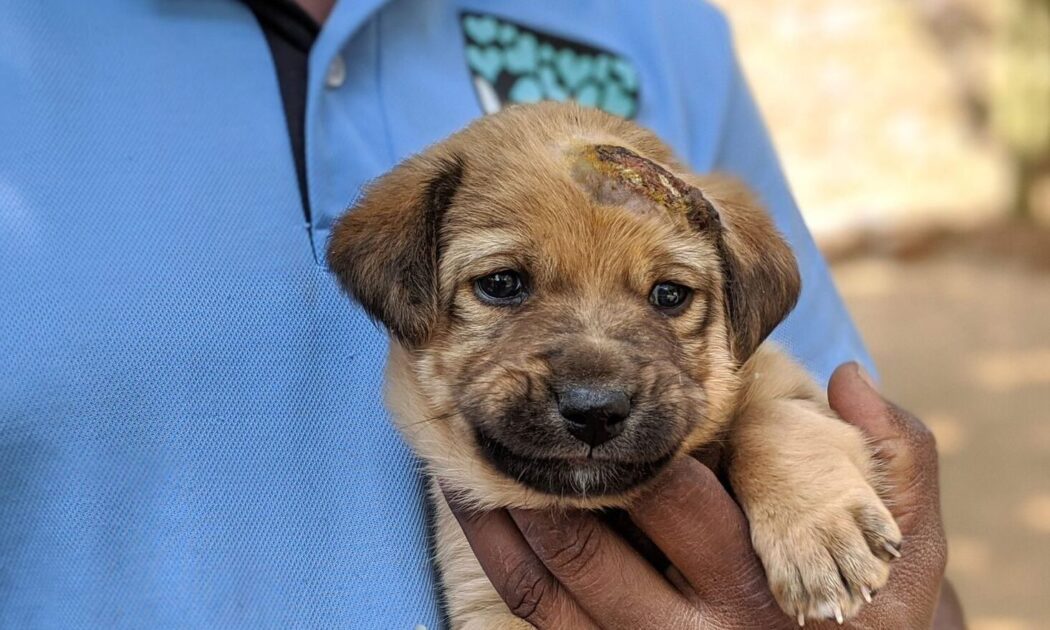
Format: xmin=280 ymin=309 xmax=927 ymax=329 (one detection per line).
xmin=833 ymin=225 xmax=1050 ymax=630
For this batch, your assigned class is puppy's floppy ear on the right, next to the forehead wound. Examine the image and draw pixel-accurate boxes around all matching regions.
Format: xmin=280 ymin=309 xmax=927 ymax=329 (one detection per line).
xmin=690 ymin=175 xmax=802 ymax=363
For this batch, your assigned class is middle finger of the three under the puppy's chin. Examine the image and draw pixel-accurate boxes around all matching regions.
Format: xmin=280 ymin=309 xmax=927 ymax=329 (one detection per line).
xmin=509 ymin=509 xmax=698 ymax=628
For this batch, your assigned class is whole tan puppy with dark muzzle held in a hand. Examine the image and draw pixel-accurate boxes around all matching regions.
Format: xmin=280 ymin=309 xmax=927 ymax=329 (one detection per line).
xmin=328 ymin=104 xmax=901 ymax=629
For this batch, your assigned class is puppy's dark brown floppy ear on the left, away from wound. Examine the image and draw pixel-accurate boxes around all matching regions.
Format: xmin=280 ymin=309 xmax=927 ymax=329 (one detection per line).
xmin=327 ymin=154 xmax=465 ymax=347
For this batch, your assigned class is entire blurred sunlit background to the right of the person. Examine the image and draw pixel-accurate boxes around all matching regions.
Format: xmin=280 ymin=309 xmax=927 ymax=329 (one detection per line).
xmin=715 ymin=0 xmax=1050 ymax=630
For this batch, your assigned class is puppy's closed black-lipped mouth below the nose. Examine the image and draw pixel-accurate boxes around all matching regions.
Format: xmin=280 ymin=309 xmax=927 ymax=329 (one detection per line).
xmin=475 ymin=428 xmax=674 ymax=497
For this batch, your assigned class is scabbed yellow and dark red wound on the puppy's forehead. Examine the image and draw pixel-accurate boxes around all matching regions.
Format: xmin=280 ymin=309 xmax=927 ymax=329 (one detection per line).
xmin=566 ymin=145 xmax=717 ymax=227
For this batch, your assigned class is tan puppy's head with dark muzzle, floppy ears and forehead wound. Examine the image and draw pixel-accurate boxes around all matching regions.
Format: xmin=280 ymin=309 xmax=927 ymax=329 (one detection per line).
xmin=328 ymin=104 xmax=799 ymax=506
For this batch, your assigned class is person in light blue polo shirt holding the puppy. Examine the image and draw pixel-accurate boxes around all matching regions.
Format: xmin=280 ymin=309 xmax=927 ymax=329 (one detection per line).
xmin=0 ymin=0 xmax=961 ymax=628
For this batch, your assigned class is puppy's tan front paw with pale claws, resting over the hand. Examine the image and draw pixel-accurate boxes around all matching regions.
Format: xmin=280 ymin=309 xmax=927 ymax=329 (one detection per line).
xmin=751 ymin=482 xmax=901 ymax=626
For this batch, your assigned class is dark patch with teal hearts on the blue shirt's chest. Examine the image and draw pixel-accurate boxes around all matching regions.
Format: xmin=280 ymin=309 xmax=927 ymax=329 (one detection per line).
xmin=460 ymin=13 xmax=639 ymax=119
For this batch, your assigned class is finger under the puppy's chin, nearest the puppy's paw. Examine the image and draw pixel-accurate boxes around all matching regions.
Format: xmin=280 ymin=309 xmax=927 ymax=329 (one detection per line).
xmin=629 ymin=458 xmax=769 ymax=602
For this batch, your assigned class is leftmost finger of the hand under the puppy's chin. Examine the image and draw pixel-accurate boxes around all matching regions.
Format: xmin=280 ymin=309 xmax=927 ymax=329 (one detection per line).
xmin=446 ymin=496 xmax=597 ymax=629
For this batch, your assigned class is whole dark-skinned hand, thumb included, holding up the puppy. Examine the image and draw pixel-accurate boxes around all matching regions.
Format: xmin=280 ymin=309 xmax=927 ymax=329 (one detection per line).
xmin=453 ymin=363 xmax=965 ymax=630
